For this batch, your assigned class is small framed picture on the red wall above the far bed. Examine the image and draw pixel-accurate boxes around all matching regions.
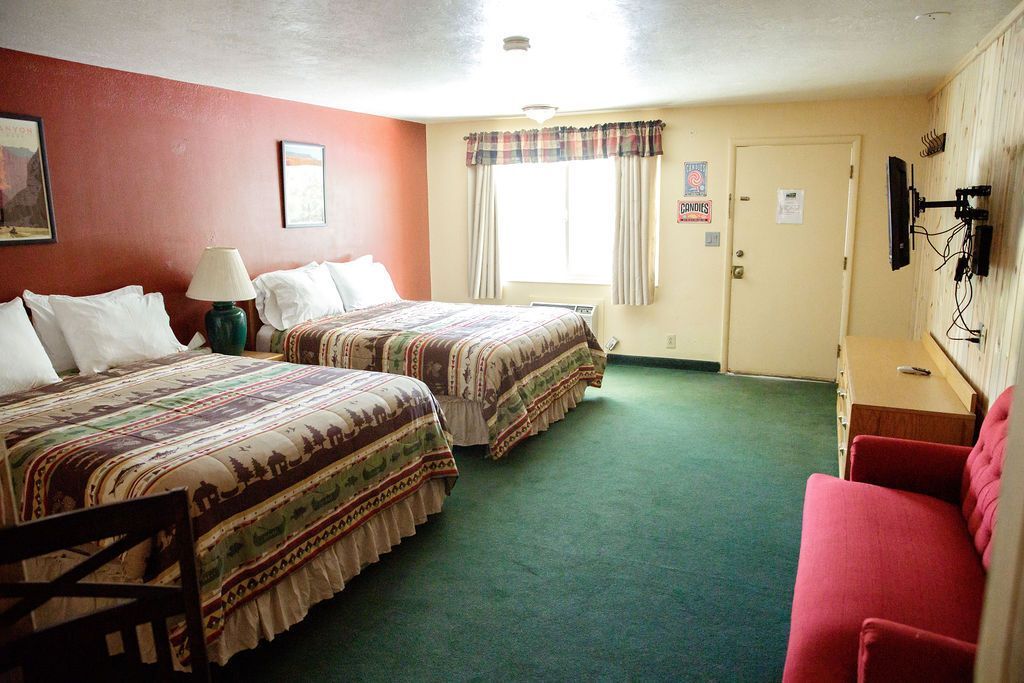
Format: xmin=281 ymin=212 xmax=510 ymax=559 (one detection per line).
xmin=281 ymin=140 xmax=327 ymax=227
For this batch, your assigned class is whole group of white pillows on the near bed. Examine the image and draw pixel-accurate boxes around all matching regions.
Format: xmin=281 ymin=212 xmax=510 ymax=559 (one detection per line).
xmin=0 ymin=286 xmax=185 ymax=395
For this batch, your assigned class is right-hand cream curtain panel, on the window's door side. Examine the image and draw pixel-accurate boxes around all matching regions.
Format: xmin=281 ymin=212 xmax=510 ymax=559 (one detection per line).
xmin=611 ymin=156 xmax=657 ymax=306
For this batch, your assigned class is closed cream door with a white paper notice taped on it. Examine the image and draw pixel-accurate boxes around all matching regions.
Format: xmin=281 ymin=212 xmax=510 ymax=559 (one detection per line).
xmin=727 ymin=142 xmax=853 ymax=379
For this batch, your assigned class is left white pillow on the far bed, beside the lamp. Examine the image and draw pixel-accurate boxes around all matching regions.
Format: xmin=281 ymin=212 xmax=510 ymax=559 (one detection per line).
xmin=253 ymin=263 xmax=345 ymax=330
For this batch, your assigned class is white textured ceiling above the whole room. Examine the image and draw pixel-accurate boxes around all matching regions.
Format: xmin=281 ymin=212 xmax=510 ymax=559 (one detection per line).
xmin=0 ymin=0 xmax=1017 ymax=122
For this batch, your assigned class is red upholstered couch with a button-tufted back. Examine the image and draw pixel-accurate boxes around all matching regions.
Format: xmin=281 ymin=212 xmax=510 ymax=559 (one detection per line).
xmin=783 ymin=388 xmax=1013 ymax=683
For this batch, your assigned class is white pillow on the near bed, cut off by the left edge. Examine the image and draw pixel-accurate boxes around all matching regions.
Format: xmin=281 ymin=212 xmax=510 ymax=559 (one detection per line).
xmin=0 ymin=297 xmax=60 ymax=396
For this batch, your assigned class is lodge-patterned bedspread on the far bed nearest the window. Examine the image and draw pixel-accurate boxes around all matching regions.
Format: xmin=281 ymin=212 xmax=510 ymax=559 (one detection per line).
xmin=270 ymin=301 xmax=605 ymax=458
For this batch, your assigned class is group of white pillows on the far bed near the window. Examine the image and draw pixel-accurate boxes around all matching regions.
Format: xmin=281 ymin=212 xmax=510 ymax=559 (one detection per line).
xmin=253 ymin=256 xmax=401 ymax=330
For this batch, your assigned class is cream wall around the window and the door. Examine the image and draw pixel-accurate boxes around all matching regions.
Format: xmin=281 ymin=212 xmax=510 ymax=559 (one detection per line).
xmin=427 ymin=96 xmax=928 ymax=361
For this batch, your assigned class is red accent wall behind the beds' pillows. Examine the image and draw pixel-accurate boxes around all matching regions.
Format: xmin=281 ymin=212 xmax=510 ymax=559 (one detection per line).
xmin=0 ymin=49 xmax=430 ymax=342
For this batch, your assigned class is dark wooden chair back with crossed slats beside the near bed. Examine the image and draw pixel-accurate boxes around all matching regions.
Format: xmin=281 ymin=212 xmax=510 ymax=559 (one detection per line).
xmin=0 ymin=488 xmax=210 ymax=681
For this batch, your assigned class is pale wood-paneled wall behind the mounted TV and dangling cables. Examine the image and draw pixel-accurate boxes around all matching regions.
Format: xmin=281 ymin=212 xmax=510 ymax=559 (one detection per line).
xmin=907 ymin=4 xmax=1024 ymax=409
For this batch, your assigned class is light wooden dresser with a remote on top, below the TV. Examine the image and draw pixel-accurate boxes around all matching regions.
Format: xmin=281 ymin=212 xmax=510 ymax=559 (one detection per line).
xmin=836 ymin=336 xmax=978 ymax=478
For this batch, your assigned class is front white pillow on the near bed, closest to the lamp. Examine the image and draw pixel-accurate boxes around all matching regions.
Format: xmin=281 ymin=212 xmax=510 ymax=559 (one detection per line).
xmin=50 ymin=293 xmax=185 ymax=375
